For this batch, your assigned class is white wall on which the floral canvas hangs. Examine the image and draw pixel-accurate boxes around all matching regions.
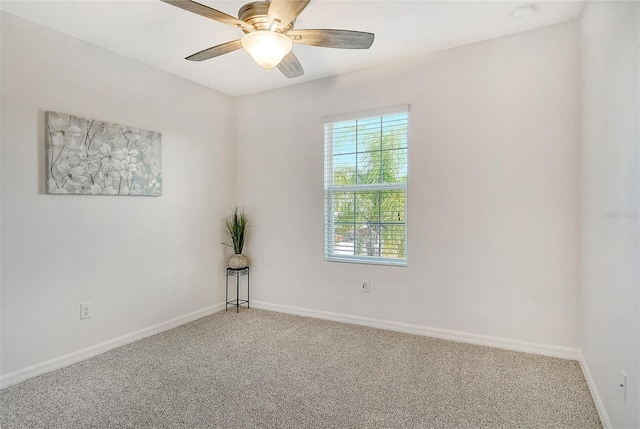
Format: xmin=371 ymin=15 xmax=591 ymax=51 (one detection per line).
xmin=1 ymin=12 xmax=235 ymax=375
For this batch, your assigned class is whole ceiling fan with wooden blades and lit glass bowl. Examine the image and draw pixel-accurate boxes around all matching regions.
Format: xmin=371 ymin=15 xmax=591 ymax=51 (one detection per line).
xmin=162 ymin=0 xmax=375 ymax=78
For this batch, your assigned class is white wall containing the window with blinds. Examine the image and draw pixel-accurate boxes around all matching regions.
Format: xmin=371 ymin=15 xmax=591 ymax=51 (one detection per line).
xmin=236 ymin=23 xmax=579 ymax=347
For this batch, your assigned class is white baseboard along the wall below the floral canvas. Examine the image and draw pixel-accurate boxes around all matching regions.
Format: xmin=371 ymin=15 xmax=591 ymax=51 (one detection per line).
xmin=0 ymin=304 xmax=224 ymax=389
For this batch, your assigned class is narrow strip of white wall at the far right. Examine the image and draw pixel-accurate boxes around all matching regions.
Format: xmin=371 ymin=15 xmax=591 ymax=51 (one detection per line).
xmin=580 ymin=2 xmax=640 ymax=428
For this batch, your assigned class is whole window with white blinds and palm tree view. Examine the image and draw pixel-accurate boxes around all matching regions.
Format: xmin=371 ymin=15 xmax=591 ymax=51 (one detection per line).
xmin=324 ymin=106 xmax=409 ymax=265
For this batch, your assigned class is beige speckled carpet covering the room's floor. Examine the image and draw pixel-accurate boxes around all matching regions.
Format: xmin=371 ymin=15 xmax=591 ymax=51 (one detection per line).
xmin=0 ymin=309 xmax=602 ymax=429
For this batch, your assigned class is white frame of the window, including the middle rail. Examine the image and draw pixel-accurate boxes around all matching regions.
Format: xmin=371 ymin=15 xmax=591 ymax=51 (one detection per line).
xmin=322 ymin=105 xmax=409 ymax=267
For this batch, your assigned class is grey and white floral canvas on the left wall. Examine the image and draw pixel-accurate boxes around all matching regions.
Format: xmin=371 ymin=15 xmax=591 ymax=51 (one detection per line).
xmin=45 ymin=112 xmax=162 ymax=196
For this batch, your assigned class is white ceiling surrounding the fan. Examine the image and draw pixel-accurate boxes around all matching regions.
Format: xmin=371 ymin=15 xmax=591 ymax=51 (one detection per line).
xmin=0 ymin=0 xmax=584 ymax=96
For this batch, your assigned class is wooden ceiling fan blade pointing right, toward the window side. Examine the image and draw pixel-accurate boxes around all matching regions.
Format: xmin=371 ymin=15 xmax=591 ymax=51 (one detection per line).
xmin=287 ymin=30 xmax=375 ymax=49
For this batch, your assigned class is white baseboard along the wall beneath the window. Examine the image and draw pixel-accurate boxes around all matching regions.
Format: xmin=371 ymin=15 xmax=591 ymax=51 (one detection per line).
xmin=251 ymin=301 xmax=580 ymax=360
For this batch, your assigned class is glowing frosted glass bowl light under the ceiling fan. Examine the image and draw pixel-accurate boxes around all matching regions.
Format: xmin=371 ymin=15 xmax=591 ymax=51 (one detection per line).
xmin=241 ymin=31 xmax=293 ymax=71
